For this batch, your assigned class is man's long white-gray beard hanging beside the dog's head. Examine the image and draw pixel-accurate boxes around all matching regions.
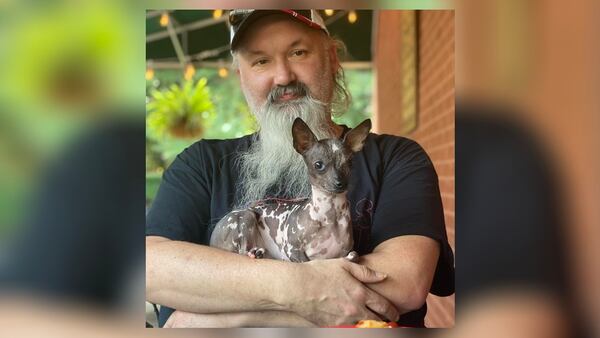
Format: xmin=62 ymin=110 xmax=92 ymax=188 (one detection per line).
xmin=235 ymin=95 xmax=335 ymax=208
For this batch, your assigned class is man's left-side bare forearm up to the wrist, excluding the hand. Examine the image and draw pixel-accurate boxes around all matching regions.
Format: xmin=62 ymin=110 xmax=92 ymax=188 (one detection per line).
xmin=146 ymin=237 xmax=292 ymax=313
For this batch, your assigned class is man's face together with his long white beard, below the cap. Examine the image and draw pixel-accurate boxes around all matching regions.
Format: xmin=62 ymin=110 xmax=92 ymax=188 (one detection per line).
xmin=236 ymin=14 xmax=337 ymax=208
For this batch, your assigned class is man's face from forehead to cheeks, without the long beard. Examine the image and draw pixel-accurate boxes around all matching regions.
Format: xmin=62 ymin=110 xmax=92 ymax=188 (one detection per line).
xmin=233 ymin=14 xmax=335 ymax=112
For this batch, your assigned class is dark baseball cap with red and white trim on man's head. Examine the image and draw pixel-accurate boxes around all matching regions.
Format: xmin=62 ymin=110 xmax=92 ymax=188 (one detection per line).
xmin=229 ymin=9 xmax=329 ymax=51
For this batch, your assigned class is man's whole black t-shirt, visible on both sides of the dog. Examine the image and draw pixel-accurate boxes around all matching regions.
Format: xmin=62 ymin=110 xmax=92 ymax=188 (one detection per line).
xmin=146 ymin=129 xmax=454 ymax=326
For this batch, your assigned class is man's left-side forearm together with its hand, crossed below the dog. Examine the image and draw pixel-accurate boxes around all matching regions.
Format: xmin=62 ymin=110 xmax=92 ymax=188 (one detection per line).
xmin=146 ymin=236 xmax=398 ymax=326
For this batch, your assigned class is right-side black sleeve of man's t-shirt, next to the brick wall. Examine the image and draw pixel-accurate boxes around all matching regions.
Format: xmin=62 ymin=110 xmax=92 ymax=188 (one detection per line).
xmin=371 ymin=139 xmax=454 ymax=296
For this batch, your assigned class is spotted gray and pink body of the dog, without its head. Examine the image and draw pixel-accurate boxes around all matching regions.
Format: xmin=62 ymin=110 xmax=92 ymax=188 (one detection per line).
xmin=211 ymin=188 xmax=354 ymax=262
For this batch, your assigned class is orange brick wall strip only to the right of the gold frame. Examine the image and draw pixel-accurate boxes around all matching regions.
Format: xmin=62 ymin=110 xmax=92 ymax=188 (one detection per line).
xmin=408 ymin=11 xmax=455 ymax=327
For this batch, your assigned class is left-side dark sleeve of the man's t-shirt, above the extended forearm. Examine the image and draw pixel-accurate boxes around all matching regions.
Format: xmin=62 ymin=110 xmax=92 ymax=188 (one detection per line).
xmin=146 ymin=142 xmax=210 ymax=243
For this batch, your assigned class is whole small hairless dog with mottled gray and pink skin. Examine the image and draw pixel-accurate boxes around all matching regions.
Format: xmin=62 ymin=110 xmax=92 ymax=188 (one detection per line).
xmin=210 ymin=119 xmax=371 ymax=262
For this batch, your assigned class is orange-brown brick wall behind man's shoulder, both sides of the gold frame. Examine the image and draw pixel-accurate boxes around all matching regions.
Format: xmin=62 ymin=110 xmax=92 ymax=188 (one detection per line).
xmin=374 ymin=11 xmax=455 ymax=327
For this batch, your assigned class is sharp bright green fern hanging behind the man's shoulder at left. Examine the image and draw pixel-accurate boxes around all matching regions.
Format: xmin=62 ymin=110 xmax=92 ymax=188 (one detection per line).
xmin=146 ymin=78 xmax=215 ymax=138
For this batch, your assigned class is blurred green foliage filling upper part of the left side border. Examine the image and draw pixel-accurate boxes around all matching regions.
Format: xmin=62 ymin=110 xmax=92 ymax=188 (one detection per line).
xmin=0 ymin=0 xmax=145 ymax=238
